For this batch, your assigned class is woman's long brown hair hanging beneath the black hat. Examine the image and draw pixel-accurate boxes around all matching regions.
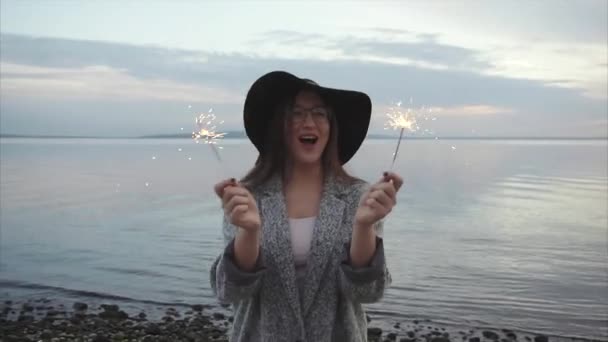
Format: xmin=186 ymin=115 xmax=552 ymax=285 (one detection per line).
xmin=241 ymin=87 xmax=357 ymax=188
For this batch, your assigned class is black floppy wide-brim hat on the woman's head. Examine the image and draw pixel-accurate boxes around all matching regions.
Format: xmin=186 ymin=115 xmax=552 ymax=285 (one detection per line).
xmin=243 ymin=71 xmax=372 ymax=164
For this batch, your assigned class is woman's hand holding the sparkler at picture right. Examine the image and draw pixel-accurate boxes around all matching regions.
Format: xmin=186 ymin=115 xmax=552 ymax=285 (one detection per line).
xmin=355 ymin=172 xmax=403 ymax=227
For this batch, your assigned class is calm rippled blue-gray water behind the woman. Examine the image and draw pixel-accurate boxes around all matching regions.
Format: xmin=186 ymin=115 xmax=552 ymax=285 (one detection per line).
xmin=0 ymin=139 xmax=608 ymax=339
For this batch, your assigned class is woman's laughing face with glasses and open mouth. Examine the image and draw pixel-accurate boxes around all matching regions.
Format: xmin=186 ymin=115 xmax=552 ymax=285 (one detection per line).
xmin=286 ymin=91 xmax=331 ymax=164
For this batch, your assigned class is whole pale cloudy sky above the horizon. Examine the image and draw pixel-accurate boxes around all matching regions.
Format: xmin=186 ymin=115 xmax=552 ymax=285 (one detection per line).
xmin=0 ymin=0 xmax=608 ymax=137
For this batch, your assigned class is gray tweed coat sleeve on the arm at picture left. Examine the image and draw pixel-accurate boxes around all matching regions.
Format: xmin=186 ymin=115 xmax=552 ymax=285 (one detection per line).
xmin=209 ymin=217 xmax=266 ymax=304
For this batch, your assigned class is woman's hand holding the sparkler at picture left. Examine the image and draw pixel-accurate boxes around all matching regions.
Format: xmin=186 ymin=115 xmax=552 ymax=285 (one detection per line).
xmin=214 ymin=178 xmax=262 ymax=233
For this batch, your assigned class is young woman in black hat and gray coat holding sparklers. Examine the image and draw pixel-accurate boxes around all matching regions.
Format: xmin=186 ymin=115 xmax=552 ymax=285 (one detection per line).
xmin=210 ymin=71 xmax=402 ymax=342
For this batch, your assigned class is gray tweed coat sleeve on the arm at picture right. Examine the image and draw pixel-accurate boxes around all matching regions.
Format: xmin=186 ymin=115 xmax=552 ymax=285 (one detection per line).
xmin=339 ymin=185 xmax=391 ymax=303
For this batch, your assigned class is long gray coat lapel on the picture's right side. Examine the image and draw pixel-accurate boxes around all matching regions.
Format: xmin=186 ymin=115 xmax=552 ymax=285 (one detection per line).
xmin=302 ymin=178 xmax=345 ymax=315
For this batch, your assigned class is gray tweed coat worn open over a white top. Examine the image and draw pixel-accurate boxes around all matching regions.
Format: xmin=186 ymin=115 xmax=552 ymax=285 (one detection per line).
xmin=210 ymin=177 xmax=390 ymax=342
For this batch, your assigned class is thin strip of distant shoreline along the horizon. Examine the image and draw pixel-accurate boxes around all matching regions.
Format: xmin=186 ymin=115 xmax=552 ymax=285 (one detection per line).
xmin=0 ymin=132 xmax=608 ymax=141
